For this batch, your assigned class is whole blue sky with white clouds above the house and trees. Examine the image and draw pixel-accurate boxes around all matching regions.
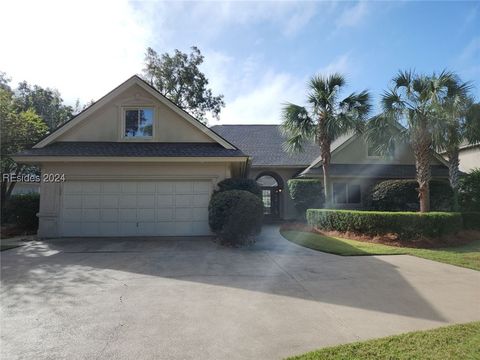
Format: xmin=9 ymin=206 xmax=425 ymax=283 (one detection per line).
xmin=0 ymin=1 xmax=480 ymax=124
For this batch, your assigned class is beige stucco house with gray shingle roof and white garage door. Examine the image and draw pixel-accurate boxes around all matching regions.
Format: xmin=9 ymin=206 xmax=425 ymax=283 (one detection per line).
xmin=14 ymin=76 xmax=448 ymax=237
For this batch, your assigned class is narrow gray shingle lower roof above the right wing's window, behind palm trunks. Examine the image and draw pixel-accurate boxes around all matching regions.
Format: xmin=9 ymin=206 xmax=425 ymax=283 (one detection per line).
xmin=301 ymin=164 xmax=448 ymax=179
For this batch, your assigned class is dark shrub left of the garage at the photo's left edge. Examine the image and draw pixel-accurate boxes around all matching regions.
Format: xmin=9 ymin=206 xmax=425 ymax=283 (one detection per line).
xmin=6 ymin=193 xmax=40 ymax=230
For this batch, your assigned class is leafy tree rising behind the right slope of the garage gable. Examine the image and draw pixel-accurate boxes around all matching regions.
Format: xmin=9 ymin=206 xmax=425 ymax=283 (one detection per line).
xmin=143 ymin=46 xmax=225 ymax=123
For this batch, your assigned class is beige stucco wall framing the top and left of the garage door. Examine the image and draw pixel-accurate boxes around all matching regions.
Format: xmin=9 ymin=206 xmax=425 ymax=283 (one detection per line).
xmin=38 ymin=163 xmax=231 ymax=237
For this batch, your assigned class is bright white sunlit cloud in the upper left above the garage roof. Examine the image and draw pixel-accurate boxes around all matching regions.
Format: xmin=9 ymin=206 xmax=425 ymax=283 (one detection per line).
xmin=0 ymin=0 xmax=151 ymax=103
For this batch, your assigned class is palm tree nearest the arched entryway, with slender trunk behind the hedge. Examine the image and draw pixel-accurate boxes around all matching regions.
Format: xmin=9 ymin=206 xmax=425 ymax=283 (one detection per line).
xmin=282 ymin=73 xmax=371 ymax=207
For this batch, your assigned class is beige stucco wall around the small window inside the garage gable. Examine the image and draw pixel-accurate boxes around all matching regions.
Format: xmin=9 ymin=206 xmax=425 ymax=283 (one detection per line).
xmin=56 ymin=85 xmax=213 ymax=142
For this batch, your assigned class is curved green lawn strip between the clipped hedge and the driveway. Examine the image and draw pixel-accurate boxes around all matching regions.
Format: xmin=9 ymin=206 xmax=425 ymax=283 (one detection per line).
xmin=280 ymin=230 xmax=480 ymax=270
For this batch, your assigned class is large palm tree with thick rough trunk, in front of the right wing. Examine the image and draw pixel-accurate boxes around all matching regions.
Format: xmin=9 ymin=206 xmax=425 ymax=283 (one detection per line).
xmin=366 ymin=71 xmax=455 ymax=212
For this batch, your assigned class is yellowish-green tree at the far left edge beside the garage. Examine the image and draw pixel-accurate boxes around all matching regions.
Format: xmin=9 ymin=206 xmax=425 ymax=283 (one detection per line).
xmin=0 ymin=89 xmax=48 ymax=210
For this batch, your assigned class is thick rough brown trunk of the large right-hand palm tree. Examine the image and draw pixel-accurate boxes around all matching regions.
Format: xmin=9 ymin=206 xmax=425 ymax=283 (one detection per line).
xmin=412 ymin=130 xmax=432 ymax=212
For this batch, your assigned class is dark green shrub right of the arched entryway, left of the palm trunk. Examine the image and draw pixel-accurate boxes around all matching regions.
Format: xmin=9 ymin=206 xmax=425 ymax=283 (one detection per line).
xmin=287 ymin=179 xmax=325 ymax=216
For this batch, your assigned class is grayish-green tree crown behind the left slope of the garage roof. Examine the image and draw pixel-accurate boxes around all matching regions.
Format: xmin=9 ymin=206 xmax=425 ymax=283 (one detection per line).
xmin=14 ymin=81 xmax=74 ymax=131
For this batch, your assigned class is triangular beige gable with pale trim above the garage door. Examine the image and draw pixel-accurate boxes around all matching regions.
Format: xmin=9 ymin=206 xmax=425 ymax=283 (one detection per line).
xmin=34 ymin=75 xmax=236 ymax=149
